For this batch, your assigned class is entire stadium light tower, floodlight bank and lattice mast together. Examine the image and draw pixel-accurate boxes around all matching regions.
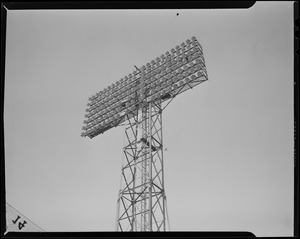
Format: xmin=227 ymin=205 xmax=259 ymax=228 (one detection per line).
xmin=81 ymin=37 xmax=208 ymax=231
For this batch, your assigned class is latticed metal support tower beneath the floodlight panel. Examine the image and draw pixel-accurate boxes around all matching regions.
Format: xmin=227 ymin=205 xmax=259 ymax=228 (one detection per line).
xmin=116 ymin=101 xmax=167 ymax=231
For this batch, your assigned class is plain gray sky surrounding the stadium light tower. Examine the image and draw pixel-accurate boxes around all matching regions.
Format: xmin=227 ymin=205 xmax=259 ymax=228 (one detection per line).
xmin=4 ymin=2 xmax=294 ymax=236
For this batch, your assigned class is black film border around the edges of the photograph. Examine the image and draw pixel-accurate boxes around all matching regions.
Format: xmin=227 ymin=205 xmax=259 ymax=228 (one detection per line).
xmin=0 ymin=1 xmax=299 ymax=238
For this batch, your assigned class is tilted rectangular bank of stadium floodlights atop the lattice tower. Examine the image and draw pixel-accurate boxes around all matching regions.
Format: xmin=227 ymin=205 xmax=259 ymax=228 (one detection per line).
xmin=81 ymin=37 xmax=208 ymax=138
